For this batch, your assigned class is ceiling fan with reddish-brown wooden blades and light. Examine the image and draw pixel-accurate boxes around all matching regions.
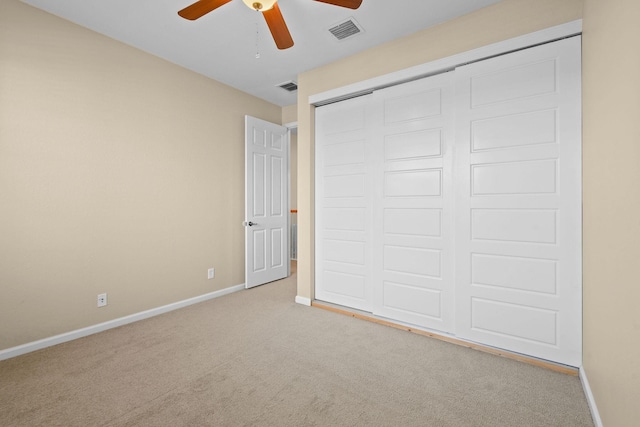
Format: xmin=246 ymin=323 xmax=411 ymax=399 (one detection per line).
xmin=178 ymin=0 xmax=362 ymax=49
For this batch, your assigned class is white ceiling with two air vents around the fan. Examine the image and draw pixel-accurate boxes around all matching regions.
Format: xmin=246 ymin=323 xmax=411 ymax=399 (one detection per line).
xmin=22 ymin=0 xmax=499 ymax=106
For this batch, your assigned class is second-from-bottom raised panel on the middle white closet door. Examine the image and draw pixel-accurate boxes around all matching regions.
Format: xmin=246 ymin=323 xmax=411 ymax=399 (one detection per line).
xmin=383 ymin=245 xmax=441 ymax=278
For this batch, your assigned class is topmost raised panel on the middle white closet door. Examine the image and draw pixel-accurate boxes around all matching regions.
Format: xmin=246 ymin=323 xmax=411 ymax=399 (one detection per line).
xmin=384 ymin=89 xmax=442 ymax=124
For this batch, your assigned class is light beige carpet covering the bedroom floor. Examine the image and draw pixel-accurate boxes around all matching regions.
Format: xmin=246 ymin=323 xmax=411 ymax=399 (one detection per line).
xmin=0 ymin=264 xmax=593 ymax=427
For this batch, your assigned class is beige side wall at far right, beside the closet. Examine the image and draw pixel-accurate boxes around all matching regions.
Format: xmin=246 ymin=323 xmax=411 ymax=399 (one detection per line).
xmin=583 ymin=0 xmax=640 ymax=427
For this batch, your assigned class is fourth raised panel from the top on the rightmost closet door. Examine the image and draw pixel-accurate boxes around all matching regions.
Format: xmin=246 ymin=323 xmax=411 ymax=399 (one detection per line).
xmin=471 ymin=209 xmax=556 ymax=243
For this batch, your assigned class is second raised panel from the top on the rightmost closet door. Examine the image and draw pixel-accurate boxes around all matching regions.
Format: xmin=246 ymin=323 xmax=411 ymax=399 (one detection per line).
xmin=471 ymin=110 xmax=556 ymax=151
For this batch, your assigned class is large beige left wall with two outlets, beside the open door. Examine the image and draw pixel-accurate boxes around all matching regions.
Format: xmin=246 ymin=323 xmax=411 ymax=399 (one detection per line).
xmin=0 ymin=0 xmax=282 ymax=349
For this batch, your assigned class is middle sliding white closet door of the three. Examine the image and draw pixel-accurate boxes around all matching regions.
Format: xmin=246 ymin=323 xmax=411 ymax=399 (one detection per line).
xmin=370 ymin=73 xmax=454 ymax=332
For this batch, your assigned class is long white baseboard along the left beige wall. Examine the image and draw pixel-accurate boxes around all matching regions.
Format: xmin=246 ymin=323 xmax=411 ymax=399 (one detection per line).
xmin=0 ymin=283 xmax=245 ymax=360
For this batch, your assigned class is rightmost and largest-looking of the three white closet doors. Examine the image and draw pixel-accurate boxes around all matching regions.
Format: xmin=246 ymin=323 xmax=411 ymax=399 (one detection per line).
xmin=455 ymin=37 xmax=582 ymax=366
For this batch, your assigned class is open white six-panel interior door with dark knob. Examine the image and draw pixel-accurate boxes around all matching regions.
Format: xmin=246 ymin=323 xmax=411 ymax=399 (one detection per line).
xmin=244 ymin=116 xmax=289 ymax=288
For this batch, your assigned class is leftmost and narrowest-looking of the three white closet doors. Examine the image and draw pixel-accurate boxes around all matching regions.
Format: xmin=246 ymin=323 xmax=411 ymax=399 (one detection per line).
xmin=316 ymin=96 xmax=373 ymax=311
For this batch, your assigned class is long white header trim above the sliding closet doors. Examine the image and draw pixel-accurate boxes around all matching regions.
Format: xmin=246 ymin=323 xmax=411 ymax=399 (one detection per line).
xmin=309 ymin=19 xmax=582 ymax=106
